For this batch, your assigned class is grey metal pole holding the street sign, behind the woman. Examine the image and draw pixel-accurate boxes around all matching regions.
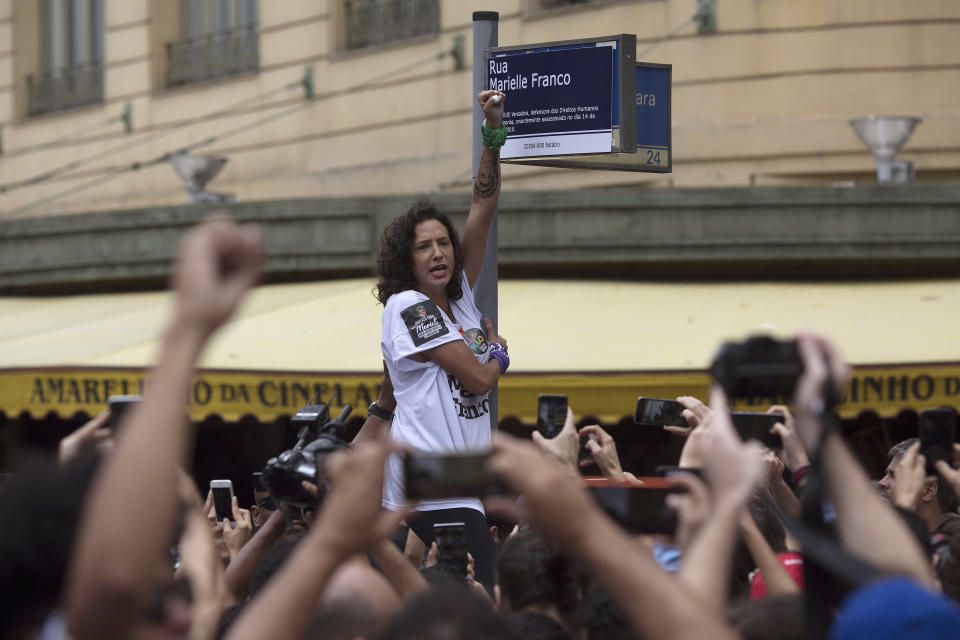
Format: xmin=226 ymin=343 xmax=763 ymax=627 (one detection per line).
xmin=471 ymin=11 xmax=500 ymax=430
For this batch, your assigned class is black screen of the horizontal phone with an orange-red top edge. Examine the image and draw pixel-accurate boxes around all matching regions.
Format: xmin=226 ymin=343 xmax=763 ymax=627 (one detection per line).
xmin=589 ymin=487 xmax=677 ymax=535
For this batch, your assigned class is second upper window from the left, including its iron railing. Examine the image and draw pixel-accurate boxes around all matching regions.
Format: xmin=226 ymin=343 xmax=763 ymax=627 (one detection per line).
xmin=166 ymin=0 xmax=260 ymax=87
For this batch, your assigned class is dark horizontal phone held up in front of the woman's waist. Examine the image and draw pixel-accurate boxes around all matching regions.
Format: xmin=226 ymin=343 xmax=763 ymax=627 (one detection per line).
xmin=403 ymin=453 xmax=497 ymax=500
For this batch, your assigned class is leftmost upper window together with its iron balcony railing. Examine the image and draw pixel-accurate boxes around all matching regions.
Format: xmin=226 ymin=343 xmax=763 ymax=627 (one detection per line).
xmin=27 ymin=0 xmax=103 ymax=116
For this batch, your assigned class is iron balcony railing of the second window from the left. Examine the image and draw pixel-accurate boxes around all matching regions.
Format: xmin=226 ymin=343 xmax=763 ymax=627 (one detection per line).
xmin=167 ymin=24 xmax=260 ymax=87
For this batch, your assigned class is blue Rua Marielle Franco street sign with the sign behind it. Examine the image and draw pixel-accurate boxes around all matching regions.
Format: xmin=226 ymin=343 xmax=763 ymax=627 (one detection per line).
xmin=486 ymin=34 xmax=672 ymax=173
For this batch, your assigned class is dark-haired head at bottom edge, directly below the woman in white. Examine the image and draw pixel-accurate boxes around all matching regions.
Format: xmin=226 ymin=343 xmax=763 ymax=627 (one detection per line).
xmin=381 ymin=587 xmax=520 ymax=640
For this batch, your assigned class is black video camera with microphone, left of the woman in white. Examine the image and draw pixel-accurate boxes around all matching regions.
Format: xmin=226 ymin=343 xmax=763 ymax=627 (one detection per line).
xmin=263 ymin=396 xmax=353 ymax=509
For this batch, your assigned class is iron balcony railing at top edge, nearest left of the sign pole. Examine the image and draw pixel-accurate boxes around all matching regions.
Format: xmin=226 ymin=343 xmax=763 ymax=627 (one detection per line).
xmin=344 ymin=0 xmax=440 ymax=49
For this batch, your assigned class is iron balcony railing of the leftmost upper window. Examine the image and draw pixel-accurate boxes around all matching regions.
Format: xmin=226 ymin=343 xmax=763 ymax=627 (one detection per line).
xmin=27 ymin=61 xmax=103 ymax=116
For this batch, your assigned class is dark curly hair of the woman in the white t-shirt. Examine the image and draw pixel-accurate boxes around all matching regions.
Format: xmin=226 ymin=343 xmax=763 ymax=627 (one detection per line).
xmin=374 ymin=201 xmax=463 ymax=305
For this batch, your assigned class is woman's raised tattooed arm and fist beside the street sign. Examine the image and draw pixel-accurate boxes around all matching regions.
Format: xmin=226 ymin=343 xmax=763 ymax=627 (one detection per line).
xmin=461 ymin=91 xmax=504 ymax=289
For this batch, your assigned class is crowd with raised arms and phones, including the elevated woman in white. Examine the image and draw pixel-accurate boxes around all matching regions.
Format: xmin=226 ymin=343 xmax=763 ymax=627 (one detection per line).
xmin=0 ymin=91 xmax=960 ymax=640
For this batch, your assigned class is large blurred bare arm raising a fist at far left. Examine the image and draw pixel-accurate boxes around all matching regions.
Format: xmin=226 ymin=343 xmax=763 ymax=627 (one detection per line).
xmin=66 ymin=218 xmax=261 ymax=640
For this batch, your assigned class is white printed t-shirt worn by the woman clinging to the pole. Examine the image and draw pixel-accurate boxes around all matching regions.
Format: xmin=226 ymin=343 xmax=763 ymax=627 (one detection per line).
xmin=380 ymin=275 xmax=490 ymax=513
